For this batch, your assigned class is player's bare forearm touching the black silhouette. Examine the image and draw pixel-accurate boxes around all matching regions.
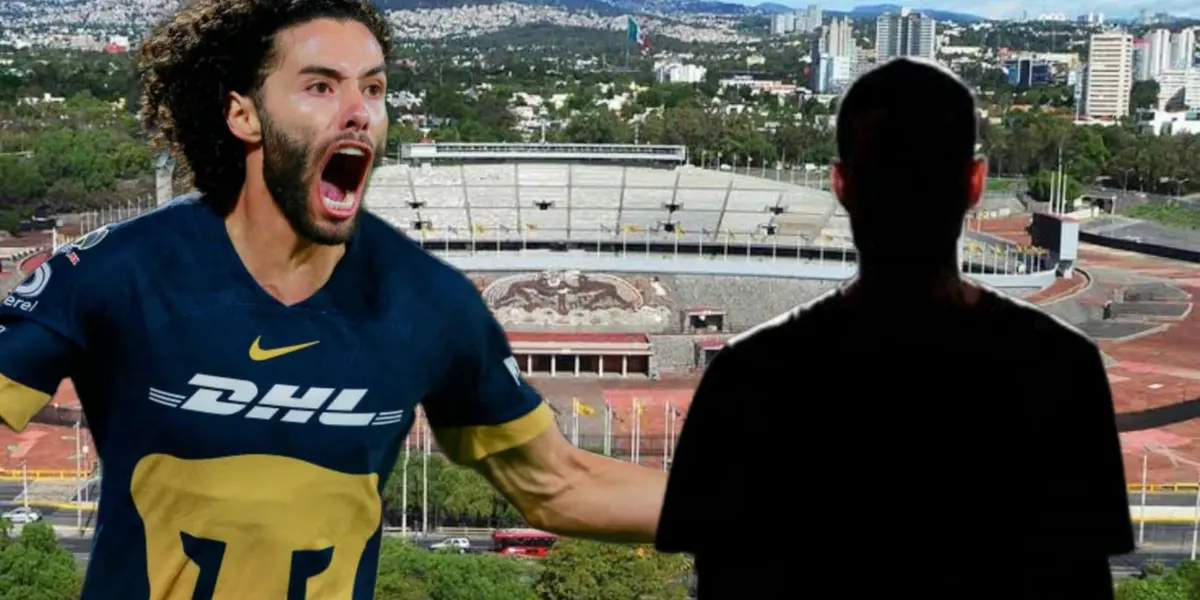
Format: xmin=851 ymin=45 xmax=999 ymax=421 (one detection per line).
xmin=526 ymin=449 xmax=667 ymax=544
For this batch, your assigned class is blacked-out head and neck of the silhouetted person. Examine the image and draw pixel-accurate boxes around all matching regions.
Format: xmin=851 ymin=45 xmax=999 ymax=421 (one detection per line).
xmin=832 ymin=58 xmax=988 ymax=268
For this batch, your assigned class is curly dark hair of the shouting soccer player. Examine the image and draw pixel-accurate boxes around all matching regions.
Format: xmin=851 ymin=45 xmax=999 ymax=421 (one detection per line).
xmin=138 ymin=0 xmax=394 ymax=212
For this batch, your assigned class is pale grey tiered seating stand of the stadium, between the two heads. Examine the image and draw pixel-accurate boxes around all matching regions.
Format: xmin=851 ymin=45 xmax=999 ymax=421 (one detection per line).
xmin=366 ymin=162 xmax=850 ymax=245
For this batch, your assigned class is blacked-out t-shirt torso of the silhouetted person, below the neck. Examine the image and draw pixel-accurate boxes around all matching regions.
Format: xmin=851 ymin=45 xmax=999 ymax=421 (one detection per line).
xmin=658 ymin=283 xmax=1133 ymax=600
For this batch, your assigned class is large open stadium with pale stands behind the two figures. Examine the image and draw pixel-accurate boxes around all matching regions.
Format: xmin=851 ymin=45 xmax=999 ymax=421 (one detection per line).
xmin=4 ymin=144 xmax=1055 ymax=469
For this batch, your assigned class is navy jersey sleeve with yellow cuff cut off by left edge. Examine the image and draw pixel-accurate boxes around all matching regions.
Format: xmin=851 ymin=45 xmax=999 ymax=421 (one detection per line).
xmin=0 ymin=251 xmax=89 ymax=431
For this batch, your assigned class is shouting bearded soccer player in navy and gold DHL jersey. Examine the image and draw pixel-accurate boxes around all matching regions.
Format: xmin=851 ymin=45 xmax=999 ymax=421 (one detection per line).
xmin=0 ymin=0 xmax=666 ymax=600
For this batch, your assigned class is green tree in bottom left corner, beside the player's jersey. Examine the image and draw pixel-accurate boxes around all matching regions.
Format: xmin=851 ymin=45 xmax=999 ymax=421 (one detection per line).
xmin=0 ymin=522 xmax=83 ymax=600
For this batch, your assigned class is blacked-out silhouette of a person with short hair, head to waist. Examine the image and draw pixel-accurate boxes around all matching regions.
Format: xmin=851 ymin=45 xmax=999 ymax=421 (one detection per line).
xmin=658 ymin=59 xmax=1133 ymax=600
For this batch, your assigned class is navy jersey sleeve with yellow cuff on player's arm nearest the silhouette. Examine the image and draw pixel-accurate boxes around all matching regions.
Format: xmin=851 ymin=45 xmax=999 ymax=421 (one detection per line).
xmin=424 ymin=287 xmax=554 ymax=463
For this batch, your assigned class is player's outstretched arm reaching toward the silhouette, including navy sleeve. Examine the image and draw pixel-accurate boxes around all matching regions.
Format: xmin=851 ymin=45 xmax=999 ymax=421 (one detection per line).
xmin=424 ymin=288 xmax=666 ymax=542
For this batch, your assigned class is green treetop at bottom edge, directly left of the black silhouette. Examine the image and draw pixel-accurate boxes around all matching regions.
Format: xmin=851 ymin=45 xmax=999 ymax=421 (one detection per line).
xmin=534 ymin=540 xmax=691 ymax=600
